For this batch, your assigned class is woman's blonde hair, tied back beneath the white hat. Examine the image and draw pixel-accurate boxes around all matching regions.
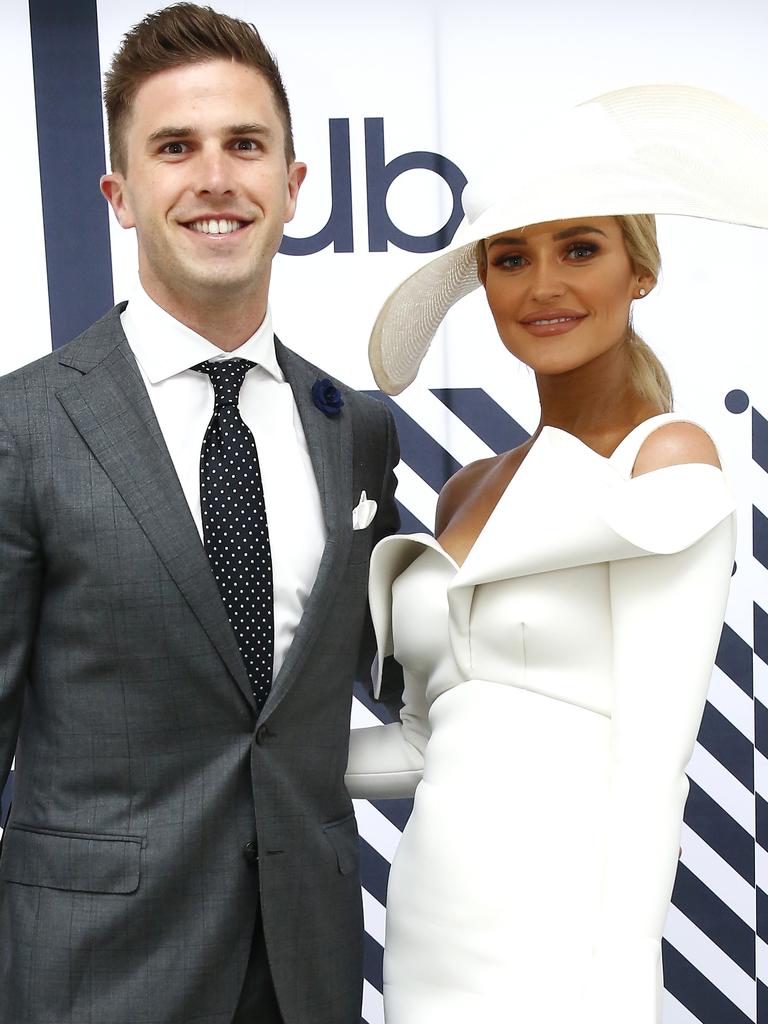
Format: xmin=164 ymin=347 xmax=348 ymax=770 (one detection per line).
xmin=476 ymin=213 xmax=672 ymax=413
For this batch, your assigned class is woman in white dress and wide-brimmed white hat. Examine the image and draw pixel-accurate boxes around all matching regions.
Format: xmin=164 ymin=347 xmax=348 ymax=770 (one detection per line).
xmin=347 ymin=87 xmax=768 ymax=1024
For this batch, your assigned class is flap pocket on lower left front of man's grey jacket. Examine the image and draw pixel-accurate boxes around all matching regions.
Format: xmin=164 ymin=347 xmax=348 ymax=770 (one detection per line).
xmin=0 ymin=824 xmax=141 ymax=893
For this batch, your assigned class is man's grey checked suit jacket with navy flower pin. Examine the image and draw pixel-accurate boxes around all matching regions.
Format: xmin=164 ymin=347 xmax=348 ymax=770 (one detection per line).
xmin=0 ymin=307 xmax=397 ymax=1024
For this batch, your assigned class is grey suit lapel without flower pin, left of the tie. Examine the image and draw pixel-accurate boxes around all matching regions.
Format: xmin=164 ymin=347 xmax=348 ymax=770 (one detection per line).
xmin=57 ymin=307 xmax=253 ymax=706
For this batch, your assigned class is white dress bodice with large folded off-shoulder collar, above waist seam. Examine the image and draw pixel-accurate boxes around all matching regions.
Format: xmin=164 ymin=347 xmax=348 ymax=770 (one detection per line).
xmin=370 ymin=414 xmax=734 ymax=715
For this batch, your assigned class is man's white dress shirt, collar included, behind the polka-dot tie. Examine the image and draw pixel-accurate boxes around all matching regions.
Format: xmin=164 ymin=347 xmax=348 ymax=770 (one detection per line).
xmin=121 ymin=287 xmax=327 ymax=678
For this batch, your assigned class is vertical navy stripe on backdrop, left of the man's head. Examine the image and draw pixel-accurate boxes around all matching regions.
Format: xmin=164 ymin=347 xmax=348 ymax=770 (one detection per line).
xmin=30 ymin=0 xmax=114 ymax=348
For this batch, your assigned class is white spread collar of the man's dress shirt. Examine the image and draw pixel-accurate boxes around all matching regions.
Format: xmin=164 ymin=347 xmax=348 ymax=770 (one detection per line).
xmin=120 ymin=285 xmax=285 ymax=384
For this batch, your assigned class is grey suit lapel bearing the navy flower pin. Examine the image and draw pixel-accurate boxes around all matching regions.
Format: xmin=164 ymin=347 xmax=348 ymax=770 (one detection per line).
xmin=264 ymin=338 xmax=354 ymax=714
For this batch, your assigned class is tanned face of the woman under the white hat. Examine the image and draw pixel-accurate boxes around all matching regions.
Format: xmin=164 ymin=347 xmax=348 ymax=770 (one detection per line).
xmin=483 ymin=217 xmax=653 ymax=375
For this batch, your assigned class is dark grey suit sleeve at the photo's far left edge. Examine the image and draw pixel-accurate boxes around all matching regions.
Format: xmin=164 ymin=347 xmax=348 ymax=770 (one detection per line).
xmin=0 ymin=407 xmax=42 ymax=790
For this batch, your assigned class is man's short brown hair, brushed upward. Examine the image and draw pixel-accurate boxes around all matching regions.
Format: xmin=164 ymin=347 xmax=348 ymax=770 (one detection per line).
xmin=104 ymin=3 xmax=295 ymax=174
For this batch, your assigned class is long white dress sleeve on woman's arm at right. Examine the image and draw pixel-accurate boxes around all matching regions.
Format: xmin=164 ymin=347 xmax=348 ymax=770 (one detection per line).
xmin=586 ymin=493 xmax=735 ymax=1024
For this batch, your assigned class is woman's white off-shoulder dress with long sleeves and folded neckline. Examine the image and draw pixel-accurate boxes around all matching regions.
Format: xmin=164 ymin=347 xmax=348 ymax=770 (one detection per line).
xmin=347 ymin=414 xmax=734 ymax=1024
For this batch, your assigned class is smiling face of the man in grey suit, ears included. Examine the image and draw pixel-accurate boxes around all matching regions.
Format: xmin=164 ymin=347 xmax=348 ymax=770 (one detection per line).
xmin=101 ymin=60 xmax=306 ymax=307
